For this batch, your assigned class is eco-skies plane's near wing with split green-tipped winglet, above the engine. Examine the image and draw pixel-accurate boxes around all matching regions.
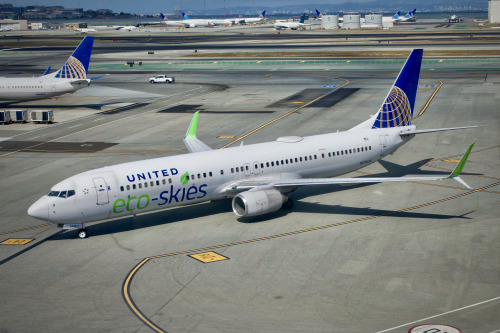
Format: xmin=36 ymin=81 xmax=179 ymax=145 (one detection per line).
xmin=226 ymin=143 xmax=474 ymax=191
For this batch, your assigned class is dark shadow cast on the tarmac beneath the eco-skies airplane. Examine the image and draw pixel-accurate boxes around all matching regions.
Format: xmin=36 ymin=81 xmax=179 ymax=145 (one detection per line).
xmin=52 ymin=159 xmax=471 ymax=240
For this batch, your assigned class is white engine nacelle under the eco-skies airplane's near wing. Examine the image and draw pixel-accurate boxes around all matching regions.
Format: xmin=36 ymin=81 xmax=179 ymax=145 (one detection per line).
xmin=232 ymin=188 xmax=288 ymax=217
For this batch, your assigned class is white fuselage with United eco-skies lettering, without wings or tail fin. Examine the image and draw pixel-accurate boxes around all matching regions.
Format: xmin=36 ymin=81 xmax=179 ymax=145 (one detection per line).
xmin=27 ymin=126 xmax=415 ymax=223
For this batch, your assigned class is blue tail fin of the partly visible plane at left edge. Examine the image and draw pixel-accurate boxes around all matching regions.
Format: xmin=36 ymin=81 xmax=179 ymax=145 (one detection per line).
xmin=55 ymin=36 xmax=94 ymax=79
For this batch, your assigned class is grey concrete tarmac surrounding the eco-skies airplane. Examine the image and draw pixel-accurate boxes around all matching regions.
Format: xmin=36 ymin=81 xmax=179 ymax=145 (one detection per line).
xmin=0 ymin=30 xmax=500 ymax=333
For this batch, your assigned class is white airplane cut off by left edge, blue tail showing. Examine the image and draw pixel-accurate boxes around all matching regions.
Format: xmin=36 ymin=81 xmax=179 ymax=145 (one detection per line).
xmin=0 ymin=36 xmax=95 ymax=101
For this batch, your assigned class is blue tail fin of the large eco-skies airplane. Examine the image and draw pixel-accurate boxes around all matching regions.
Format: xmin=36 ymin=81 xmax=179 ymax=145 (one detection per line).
xmin=372 ymin=49 xmax=424 ymax=128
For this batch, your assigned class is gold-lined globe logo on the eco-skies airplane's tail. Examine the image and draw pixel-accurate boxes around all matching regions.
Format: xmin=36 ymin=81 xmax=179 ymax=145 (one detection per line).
xmin=373 ymin=86 xmax=412 ymax=128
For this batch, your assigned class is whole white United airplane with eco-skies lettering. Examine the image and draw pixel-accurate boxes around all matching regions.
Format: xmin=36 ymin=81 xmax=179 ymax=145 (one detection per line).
xmin=28 ymin=49 xmax=477 ymax=238
